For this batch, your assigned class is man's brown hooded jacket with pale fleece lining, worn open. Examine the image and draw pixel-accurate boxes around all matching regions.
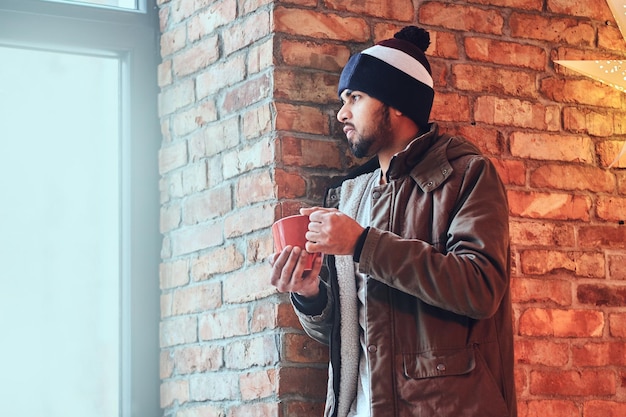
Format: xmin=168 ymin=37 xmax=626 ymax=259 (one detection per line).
xmin=292 ymin=124 xmax=517 ymax=417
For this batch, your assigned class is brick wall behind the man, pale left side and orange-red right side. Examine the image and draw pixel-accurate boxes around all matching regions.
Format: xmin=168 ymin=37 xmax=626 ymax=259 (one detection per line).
xmin=158 ymin=0 xmax=626 ymax=417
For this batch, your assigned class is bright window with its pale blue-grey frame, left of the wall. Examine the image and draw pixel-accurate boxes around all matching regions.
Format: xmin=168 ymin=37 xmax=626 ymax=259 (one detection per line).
xmin=0 ymin=0 xmax=161 ymax=417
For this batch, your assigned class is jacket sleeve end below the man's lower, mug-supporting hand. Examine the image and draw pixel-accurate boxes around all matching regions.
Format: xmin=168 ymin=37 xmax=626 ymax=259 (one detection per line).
xmin=291 ymin=280 xmax=334 ymax=345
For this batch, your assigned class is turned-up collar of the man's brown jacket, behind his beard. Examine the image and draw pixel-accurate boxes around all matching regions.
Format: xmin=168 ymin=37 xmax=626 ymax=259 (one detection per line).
xmin=387 ymin=123 xmax=452 ymax=192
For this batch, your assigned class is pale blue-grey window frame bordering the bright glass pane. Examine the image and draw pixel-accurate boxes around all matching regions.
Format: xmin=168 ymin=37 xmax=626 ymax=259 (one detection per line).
xmin=0 ymin=0 xmax=161 ymax=417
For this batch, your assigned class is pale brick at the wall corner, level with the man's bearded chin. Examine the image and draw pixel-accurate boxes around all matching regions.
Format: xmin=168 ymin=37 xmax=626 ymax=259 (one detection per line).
xmin=221 ymin=138 xmax=274 ymax=179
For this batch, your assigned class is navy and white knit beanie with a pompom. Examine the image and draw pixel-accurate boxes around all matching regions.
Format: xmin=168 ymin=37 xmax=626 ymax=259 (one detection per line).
xmin=337 ymin=26 xmax=435 ymax=128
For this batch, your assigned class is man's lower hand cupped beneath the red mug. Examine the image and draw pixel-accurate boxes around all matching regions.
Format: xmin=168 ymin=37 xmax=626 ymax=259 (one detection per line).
xmin=270 ymin=246 xmax=322 ymax=298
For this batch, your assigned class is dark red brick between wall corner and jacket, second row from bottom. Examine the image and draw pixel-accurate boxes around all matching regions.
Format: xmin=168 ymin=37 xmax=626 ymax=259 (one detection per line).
xmin=278 ymin=367 xmax=328 ymax=398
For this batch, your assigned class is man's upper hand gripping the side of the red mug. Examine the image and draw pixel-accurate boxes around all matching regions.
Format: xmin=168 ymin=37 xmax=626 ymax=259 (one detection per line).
xmin=300 ymin=207 xmax=365 ymax=255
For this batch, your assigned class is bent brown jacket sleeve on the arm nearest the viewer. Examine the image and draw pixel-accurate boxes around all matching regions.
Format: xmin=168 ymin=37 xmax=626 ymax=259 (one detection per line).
xmin=359 ymin=157 xmax=509 ymax=319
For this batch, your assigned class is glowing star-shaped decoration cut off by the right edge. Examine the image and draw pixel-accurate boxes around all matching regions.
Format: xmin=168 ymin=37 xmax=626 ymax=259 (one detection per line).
xmin=554 ymin=0 xmax=626 ymax=169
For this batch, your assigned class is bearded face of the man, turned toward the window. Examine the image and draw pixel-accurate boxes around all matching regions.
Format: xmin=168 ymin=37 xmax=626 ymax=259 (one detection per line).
xmin=337 ymin=90 xmax=391 ymax=158
